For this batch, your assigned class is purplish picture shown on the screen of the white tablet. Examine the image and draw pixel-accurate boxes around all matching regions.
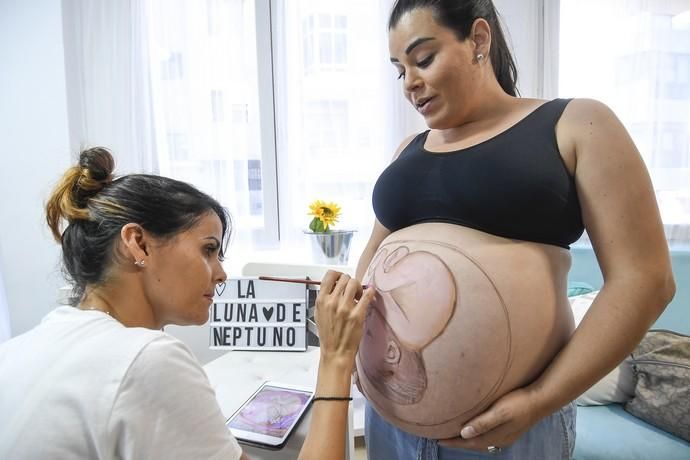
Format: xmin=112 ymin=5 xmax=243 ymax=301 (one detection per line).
xmin=228 ymin=385 xmax=309 ymax=438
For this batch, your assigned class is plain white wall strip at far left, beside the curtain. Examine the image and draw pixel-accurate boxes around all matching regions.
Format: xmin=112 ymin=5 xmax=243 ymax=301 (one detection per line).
xmin=0 ymin=0 xmax=70 ymax=335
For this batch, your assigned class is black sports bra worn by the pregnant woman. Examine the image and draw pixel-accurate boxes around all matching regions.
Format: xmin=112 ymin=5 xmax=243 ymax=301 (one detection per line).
xmin=372 ymin=99 xmax=584 ymax=249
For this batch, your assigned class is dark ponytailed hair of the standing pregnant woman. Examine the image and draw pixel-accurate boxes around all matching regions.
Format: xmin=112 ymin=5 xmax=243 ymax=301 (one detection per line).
xmin=388 ymin=0 xmax=518 ymax=96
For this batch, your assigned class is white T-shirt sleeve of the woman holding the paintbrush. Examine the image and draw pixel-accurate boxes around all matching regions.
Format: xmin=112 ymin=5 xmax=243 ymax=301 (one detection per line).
xmin=108 ymin=331 xmax=242 ymax=458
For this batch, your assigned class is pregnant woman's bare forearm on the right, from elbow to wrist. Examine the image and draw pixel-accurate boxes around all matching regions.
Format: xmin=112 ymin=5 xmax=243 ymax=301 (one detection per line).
xmin=529 ymin=274 xmax=675 ymax=416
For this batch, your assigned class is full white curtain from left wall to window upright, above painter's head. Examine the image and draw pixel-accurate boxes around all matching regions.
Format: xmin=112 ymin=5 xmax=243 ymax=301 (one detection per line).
xmin=63 ymin=0 xmax=268 ymax=253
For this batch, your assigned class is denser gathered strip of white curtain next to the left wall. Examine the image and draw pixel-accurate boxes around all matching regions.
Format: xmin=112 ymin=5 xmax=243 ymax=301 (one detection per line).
xmin=63 ymin=0 xmax=158 ymax=174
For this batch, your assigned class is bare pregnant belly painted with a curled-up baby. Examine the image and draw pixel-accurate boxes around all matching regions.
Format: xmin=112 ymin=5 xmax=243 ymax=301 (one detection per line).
xmin=357 ymin=225 xmax=568 ymax=438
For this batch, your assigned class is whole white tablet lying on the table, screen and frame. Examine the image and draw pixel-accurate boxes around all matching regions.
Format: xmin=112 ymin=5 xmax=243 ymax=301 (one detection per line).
xmin=226 ymin=381 xmax=314 ymax=449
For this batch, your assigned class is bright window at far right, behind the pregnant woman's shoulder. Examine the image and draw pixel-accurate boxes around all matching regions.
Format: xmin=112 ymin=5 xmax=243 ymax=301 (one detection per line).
xmin=559 ymin=0 xmax=690 ymax=243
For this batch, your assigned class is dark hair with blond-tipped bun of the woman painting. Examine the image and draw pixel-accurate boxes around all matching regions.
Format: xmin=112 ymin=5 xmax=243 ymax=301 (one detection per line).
xmin=46 ymin=147 xmax=232 ymax=302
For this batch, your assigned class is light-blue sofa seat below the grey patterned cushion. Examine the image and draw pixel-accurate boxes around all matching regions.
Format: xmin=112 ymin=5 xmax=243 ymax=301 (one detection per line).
xmin=574 ymin=404 xmax=690 ymax=460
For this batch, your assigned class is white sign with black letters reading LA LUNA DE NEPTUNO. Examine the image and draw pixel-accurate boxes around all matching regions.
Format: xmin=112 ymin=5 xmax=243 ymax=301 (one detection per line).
xmin=209 ymin=278 xmax=308 ymax=351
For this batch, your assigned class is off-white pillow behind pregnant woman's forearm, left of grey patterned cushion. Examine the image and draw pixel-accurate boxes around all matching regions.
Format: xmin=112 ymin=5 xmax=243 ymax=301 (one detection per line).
xmin=570 ymin=291 xmax=635 ymax=406
